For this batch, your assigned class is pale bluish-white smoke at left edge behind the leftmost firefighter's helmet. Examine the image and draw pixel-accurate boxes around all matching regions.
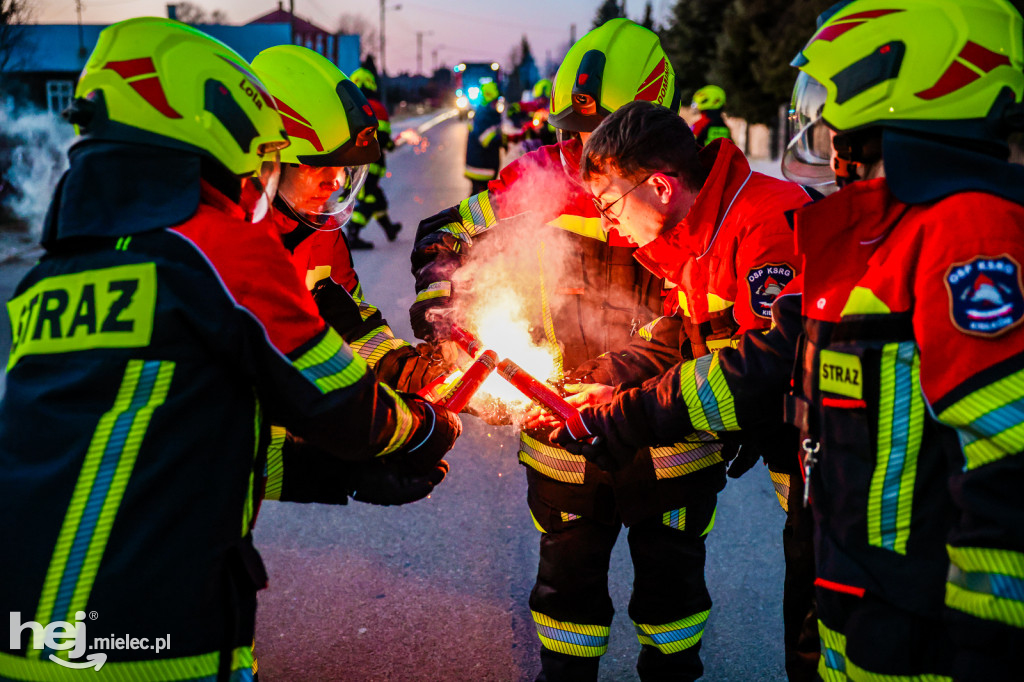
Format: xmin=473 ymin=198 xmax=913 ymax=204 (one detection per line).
xmin=0 ymin=101 xmax=75 ymax=239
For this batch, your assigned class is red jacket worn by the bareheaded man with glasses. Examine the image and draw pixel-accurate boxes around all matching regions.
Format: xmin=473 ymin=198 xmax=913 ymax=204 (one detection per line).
xmin=592 ymin=140 xmax=809 ymax=501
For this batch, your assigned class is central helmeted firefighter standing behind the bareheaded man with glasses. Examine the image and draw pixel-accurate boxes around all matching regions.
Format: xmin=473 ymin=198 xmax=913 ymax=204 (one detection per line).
xmin=411 ymin=18 xmax=725 ymax=681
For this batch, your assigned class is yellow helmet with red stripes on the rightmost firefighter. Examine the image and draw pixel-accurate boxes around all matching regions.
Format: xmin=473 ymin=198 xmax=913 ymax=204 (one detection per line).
xmin=793 ymin=0 xmax=1024 ymax=137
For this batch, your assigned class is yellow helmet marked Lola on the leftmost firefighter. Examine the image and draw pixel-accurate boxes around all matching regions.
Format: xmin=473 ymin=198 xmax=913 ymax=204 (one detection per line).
xmin=68 ymin=17 xmax=288 ymax=176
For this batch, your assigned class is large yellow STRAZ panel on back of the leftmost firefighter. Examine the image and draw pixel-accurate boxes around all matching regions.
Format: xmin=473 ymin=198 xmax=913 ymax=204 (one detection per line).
xmin=7 ymin=263 xmax=157 ymax=370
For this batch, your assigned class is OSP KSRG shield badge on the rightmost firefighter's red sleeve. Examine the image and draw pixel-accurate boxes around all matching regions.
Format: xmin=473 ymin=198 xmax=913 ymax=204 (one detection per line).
xmin=945 ymin=254 xmax=1024 ymax=336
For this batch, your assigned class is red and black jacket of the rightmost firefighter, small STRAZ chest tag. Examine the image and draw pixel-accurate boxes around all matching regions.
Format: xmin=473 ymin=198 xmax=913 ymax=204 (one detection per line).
xmin=587 ymin=174 xmax=1024 ymax=680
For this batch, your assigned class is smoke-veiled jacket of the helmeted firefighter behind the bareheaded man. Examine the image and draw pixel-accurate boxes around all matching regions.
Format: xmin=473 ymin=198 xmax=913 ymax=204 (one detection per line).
xmin=411 ymin=145 xmax=724 ymax=526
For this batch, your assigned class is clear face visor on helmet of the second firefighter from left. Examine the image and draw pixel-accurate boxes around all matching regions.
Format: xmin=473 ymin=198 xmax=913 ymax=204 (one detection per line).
xmin=278 ymin=164 xmax=369 ymax=231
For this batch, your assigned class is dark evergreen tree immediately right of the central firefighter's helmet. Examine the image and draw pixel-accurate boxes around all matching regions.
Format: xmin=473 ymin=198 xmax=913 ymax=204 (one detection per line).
xmin=659 ymin=0 xmax=729 ymax=104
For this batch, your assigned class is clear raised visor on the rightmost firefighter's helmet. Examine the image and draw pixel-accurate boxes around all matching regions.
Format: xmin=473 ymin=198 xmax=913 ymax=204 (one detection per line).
xmin=782 ymin=72 xmax=836 ymax=186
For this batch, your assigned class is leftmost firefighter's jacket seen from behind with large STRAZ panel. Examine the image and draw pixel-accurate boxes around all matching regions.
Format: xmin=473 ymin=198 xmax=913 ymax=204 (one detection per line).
xmin=0 ymin=143 xmax=419 ymax=681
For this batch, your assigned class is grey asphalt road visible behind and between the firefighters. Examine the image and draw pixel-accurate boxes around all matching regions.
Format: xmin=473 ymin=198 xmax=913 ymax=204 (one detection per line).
xmin=0 ymin=114 xmax=784 ymax=682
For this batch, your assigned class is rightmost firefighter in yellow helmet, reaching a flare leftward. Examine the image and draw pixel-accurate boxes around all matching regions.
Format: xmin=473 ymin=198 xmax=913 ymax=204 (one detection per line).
xmin=556 ymin=0 xmax=1024 ymax=682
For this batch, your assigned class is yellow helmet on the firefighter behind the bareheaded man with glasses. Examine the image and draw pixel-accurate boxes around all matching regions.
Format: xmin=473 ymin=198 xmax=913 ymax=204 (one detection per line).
xmin=549 ymin=18 xmax=679 ymax=132
